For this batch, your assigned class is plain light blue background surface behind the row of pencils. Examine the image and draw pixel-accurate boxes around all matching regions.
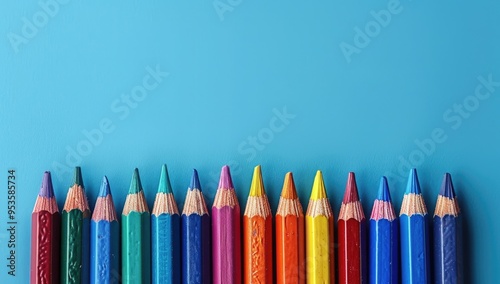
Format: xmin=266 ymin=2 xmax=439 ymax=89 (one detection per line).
xmin=0 ymin=0 xmax=500 ymax=283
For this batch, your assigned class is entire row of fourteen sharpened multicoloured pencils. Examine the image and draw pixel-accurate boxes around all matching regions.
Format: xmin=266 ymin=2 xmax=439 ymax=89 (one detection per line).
xmin=30 ymin=166 xmax=463 ymax=284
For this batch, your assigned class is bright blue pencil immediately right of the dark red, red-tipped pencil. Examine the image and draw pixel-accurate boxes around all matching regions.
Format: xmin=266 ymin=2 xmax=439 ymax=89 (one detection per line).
xmin=368 ymin=177 xmax=399 ymax=284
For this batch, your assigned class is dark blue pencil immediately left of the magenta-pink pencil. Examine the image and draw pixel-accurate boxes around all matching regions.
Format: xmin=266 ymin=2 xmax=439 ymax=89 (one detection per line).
xmin=181 ymin=170 xmax=211 ymax=284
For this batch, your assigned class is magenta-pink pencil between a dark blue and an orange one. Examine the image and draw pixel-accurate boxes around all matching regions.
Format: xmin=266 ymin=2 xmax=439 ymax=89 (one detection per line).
xmin=212 ymin=166 xmax=241 ymax=284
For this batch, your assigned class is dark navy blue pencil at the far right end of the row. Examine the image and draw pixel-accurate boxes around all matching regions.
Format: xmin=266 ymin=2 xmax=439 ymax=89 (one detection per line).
xmin=434 ymin=173 xmax=464 ymax=284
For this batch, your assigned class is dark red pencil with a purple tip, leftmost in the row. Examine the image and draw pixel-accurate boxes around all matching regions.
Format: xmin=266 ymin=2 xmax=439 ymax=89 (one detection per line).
xmin=30 ymin=172 xmax=61 ymax=284
